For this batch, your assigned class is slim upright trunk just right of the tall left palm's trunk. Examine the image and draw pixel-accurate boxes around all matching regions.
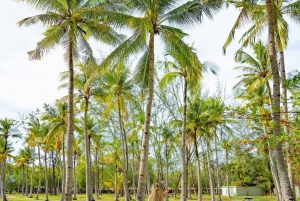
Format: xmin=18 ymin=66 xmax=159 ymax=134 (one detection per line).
xmin=83 ymin=98 xmax=92 ymax=201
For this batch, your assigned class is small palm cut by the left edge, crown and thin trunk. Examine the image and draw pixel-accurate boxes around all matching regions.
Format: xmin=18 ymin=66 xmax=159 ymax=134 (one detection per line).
xmin=0 ymin=118 xmax=21 ymax=201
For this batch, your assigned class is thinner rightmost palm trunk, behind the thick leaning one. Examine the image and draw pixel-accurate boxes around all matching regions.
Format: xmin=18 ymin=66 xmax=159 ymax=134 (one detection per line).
xmin=280 ymin=50 xmax=296 ymax=199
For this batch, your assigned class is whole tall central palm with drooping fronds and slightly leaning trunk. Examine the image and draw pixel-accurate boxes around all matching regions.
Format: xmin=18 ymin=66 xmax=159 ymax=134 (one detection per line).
xmin=100 ymin=0 xmax=220 ymax=201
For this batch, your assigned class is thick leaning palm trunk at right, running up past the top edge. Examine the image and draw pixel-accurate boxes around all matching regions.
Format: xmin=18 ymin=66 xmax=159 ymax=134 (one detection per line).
xmin=266 ymin=0 xmax=294 ymax=201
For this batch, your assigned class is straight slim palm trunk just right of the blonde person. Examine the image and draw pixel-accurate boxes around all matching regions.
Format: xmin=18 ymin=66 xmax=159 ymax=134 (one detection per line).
xmin=180 ymin=78 xmax=187 ymax=201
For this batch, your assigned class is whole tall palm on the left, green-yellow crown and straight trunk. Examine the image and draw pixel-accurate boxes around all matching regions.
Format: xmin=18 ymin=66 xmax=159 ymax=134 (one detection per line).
xmin=18 ymin=0 xmax=122 ymax=201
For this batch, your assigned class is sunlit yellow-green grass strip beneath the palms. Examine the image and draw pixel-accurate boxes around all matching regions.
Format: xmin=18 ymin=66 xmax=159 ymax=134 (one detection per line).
xmin=7 ymin=194 xmax=282 ymax=201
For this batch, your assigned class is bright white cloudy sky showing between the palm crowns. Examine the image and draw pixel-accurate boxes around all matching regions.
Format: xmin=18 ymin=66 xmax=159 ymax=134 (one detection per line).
xmin=0 ymin=0 xmax=300 ymax=121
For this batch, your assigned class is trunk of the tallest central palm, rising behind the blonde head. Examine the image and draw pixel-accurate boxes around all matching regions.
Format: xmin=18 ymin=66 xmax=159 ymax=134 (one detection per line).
xmin=137 ymin=33 xmax=154 ymax=201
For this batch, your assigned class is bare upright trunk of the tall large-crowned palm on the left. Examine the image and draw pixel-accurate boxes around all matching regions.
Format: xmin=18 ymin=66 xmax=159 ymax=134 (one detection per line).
xmin=65 ymin=39 xmax=74 ymax=201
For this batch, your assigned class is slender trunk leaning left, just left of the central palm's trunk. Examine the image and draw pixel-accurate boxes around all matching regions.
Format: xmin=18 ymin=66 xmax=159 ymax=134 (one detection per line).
xmin=117 ymin=96 xmax=130 ymax=201
